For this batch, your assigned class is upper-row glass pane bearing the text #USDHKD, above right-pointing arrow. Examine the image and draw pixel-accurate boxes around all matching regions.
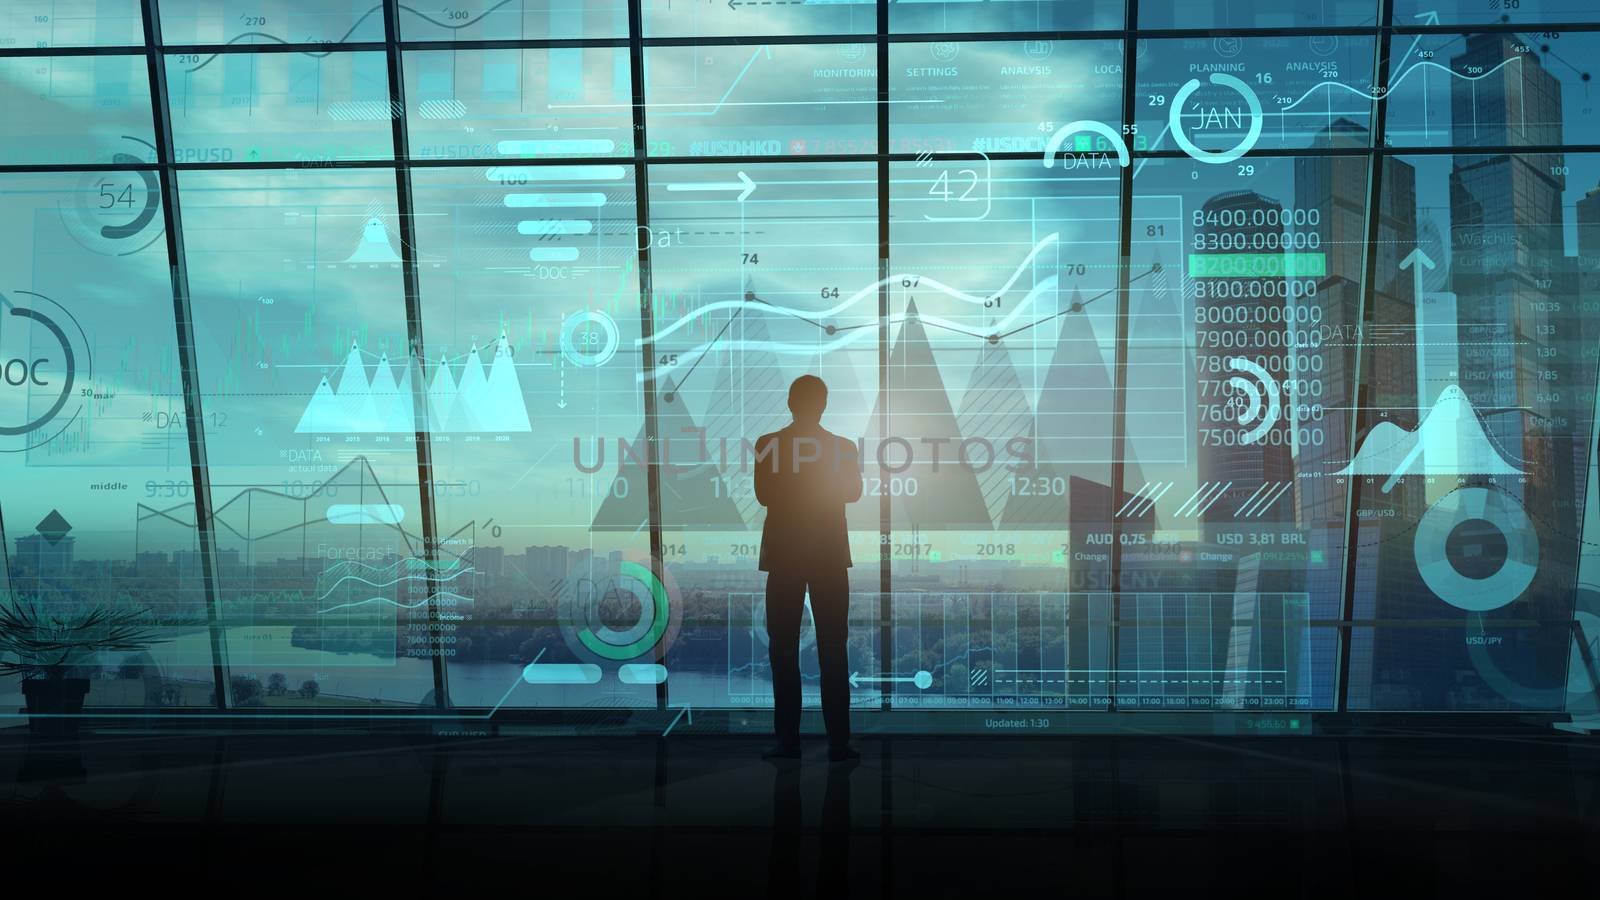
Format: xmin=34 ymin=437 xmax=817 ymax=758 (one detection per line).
xmin=645 ymin=43 xmax=878 ymax=157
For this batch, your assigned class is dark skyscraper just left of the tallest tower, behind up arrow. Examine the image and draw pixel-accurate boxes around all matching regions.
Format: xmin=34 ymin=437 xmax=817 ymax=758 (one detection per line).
xmin=1293 ymin=119 xmax=1426 ymax=707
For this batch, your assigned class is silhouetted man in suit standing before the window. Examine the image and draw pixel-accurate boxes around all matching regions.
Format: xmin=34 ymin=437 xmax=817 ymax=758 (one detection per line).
xmin=755 ymin=375 xmax=861 ymax=762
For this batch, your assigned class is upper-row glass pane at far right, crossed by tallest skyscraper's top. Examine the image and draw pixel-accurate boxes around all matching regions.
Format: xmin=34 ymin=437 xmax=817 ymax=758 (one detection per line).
xmin=1387 ymin=32 xmax=1600 ymax=147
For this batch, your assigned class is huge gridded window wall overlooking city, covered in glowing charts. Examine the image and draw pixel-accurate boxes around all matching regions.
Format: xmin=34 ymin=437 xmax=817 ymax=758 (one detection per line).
xmin=0 ymin=0 xmax=1600 ymax=717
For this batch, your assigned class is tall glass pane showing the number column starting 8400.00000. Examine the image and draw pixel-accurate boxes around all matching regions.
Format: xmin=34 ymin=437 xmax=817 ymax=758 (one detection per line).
xmin=1117 ymin=153 xmax=1363 ymax=709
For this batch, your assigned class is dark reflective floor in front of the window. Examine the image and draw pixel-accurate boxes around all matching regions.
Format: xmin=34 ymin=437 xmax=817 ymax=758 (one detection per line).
xmin=0 ymin=729 xmax=1600 ymax=898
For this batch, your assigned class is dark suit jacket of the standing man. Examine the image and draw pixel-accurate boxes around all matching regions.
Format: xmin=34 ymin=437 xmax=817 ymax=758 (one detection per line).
xmin=754 ymin=424 xmax=861 ymax=572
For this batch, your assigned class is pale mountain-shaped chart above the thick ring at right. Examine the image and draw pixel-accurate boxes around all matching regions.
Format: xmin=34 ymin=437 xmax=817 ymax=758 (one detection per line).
xmin=1334 ymin=384 xmax=1523 ymax=490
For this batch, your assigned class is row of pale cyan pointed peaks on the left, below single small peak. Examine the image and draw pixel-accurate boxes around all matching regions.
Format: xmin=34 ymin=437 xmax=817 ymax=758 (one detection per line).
xmin=294 ymin=335 xmax=533 ymax=434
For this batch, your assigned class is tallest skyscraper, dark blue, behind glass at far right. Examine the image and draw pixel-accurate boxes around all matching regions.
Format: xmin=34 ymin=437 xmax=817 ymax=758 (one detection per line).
xmin=1438 ymin=34 xmax=1568 ymax=701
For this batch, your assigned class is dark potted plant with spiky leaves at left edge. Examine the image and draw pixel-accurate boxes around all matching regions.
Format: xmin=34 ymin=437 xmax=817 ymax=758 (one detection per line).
xmin=0 ymin=601 xmax=158 ymax=737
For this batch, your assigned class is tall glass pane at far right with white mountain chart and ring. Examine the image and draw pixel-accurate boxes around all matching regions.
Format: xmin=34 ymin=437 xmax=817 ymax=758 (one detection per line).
xmin=1350 ymin=154 xmax=1600 ymax=709
